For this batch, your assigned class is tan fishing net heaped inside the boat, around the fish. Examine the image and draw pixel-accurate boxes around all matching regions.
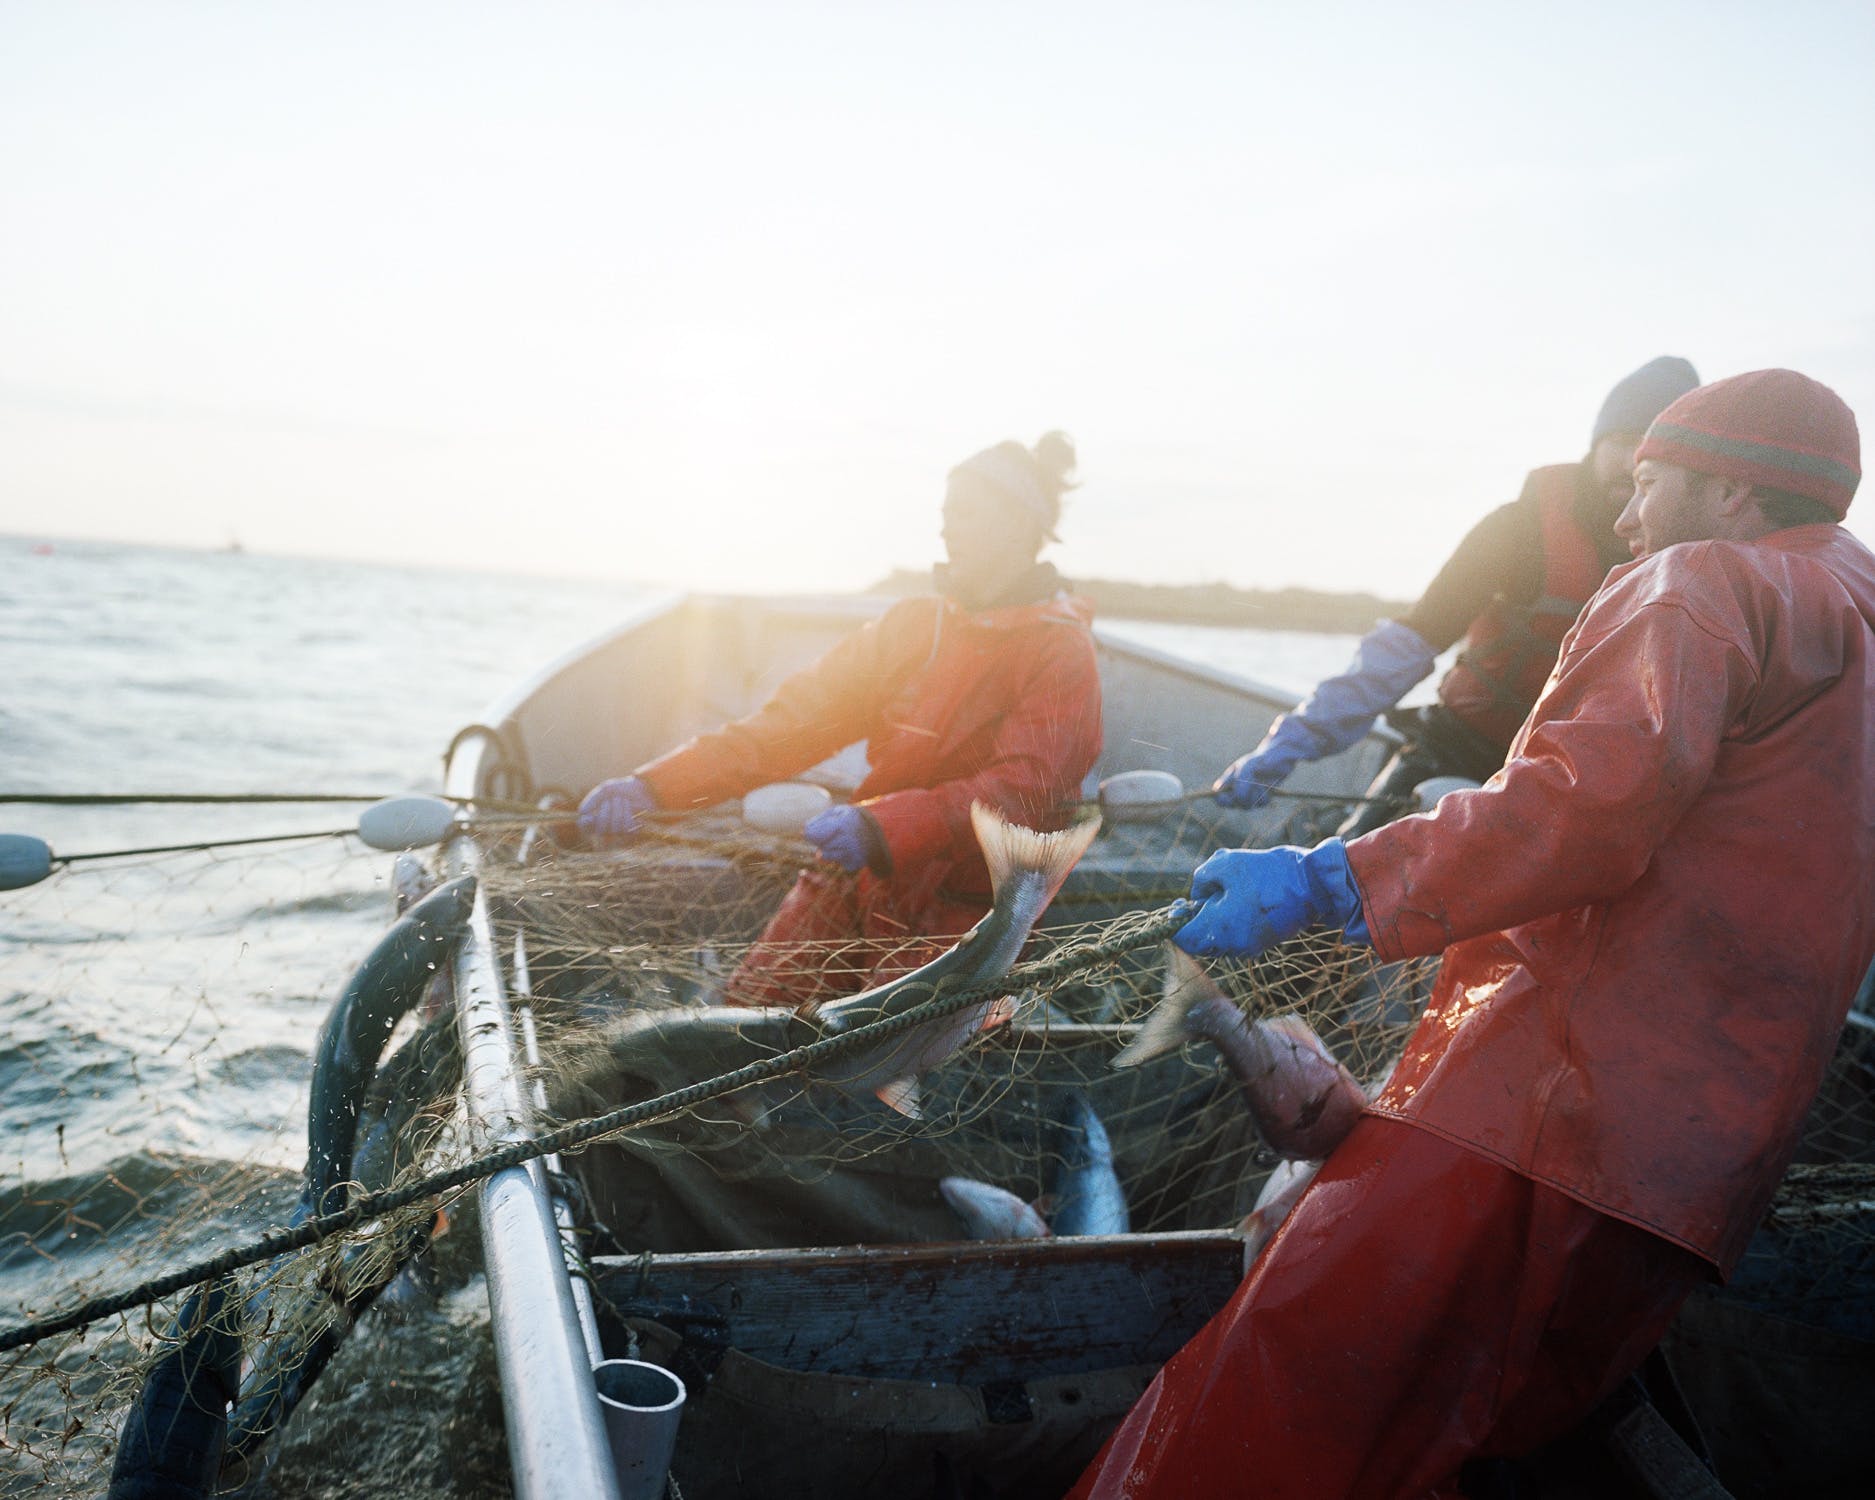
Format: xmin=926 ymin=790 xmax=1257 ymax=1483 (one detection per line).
xmin=488 ymin=821 xmax=1431 ymax=1251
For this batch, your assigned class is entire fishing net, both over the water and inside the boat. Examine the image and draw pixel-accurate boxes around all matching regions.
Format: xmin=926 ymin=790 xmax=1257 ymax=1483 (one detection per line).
xmin=0 ymin=804 xmax=1875 ymax=1496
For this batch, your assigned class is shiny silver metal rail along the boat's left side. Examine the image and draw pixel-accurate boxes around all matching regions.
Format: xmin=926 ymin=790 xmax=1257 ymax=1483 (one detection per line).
xmin=450 ymin=834 xmax=619 ymax=1500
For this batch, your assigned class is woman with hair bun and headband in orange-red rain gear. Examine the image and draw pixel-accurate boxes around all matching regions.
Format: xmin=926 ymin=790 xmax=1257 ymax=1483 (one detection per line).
xmin=579 ymin=433 xmax=1101 ymax=1005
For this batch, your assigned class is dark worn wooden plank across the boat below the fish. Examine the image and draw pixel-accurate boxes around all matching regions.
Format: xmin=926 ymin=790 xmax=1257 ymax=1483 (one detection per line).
xmin=593 ymin=1230 xmax=1245 ymax=1386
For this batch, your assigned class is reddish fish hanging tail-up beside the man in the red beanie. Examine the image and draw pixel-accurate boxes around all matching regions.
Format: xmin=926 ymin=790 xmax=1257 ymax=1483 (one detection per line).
xmin=1114 ymin=947 xmax=1367 ymax=1161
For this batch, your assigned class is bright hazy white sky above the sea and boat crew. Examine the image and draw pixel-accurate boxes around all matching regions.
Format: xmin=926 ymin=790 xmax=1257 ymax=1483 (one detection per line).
xmin=0 ymin=0 xmax=1875 ymax=598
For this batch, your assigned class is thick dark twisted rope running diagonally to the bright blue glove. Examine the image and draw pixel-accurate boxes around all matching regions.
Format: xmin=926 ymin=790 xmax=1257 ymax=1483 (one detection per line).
xmin=0 ymin=906 xmax=1191 ymax=1354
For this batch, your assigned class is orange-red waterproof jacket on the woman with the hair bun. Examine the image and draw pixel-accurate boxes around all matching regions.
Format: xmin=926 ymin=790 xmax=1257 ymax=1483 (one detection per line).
xmin=638 ymin=570 xmax=1101 ymax=900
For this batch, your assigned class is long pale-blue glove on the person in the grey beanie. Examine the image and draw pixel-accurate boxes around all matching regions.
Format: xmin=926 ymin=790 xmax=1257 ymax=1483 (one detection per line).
xmin=1211 ymin=621 xmax=1436 ymax=808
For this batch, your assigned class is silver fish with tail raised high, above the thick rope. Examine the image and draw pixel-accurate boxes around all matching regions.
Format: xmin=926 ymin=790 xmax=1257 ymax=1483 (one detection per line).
xmin=808 ymin=803 xmax=1101 ymax=1119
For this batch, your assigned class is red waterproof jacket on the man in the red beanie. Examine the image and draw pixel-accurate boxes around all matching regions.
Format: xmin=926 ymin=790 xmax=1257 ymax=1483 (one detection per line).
xmin=1348 ymin=525 xmax=1875 ymax=1271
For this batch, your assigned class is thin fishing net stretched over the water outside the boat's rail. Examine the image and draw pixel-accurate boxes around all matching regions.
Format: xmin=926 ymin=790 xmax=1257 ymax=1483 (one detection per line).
xmin=0 ymin=836 xmax=476 ymax=1494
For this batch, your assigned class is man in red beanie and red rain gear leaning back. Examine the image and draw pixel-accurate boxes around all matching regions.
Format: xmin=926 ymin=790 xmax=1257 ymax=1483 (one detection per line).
xmin=1074 ymin=369 xmax=1875 ymax=1500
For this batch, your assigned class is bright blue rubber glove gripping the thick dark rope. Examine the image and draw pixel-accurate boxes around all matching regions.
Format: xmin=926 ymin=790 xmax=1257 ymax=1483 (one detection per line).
xmin=1172 ymin=838 xmax=1373 ymax=958
